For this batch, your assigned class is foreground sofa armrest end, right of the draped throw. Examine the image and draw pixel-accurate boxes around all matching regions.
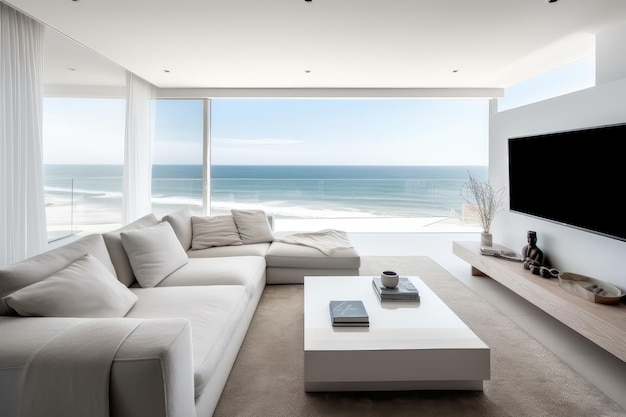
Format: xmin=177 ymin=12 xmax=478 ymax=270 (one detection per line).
xmin=110 ymin=319 xmax=197 ymax=417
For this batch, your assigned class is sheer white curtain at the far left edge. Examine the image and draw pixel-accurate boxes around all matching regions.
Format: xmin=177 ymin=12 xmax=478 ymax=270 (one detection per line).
xmin=0 ymin=3 xmax=47 ymax=266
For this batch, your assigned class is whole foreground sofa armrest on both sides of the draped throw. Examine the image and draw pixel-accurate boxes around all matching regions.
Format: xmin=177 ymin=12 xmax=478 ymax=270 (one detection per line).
xmin=0 ymin=316 xmax=197 ymax=417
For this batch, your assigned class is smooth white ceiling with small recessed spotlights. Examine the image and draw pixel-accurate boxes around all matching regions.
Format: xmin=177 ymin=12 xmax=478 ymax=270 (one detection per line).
xmin=3 ymin=0 xmax=626 ymax=89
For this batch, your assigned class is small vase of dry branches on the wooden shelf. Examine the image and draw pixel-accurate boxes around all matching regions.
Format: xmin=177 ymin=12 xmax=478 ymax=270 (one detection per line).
xmin=461 ymin=173 xmax=504 ymax=246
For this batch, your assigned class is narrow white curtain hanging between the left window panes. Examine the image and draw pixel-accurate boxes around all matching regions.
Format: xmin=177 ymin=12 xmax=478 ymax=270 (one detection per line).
xmin=124 ymin=72 xmax=156 ymax=223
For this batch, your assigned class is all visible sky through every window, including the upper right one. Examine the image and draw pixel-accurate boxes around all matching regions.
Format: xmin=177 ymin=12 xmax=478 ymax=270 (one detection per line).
xmin=44 ymin=57 xmax=595 ymax=165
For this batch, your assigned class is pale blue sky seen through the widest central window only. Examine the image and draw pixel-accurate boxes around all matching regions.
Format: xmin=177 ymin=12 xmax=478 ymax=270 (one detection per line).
xmin=212 ymin=99 xmax=488 ymax=165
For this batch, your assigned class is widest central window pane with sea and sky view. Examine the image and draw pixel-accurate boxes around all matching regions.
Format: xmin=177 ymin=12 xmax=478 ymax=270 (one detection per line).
xmin=211 ymin=99 xmax=489 ymax=221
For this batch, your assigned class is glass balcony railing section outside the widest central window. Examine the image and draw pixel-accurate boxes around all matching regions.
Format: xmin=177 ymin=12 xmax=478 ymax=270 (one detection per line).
xmin=211 ymin=179 xmax=466 ymax=218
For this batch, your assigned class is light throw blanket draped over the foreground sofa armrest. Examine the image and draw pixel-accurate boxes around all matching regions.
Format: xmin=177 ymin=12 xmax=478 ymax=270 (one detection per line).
xmin=21 ymin=319 xmax=141 ymax=417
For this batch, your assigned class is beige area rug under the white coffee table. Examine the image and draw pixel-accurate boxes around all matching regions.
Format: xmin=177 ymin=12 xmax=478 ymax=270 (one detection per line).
xmin=214 ymin=256 xmax=626 ymax=417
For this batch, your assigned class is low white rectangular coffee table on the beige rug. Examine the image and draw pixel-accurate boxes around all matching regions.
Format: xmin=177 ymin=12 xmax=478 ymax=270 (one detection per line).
xmin=304 ymin=276 xmax=490 ymax=392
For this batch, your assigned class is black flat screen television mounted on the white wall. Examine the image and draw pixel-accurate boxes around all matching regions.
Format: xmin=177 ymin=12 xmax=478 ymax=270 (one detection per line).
xmin=508 ymin=124 xmax=626 ymax=241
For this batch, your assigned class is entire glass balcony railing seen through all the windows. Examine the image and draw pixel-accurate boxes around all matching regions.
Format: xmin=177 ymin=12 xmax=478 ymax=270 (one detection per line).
xmin=45 ymin=177 xmax=475 ymax=240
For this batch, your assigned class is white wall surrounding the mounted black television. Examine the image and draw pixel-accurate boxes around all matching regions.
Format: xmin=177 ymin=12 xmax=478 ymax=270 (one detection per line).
xmin=489 ymin=78 xmax=626 ymax=290
